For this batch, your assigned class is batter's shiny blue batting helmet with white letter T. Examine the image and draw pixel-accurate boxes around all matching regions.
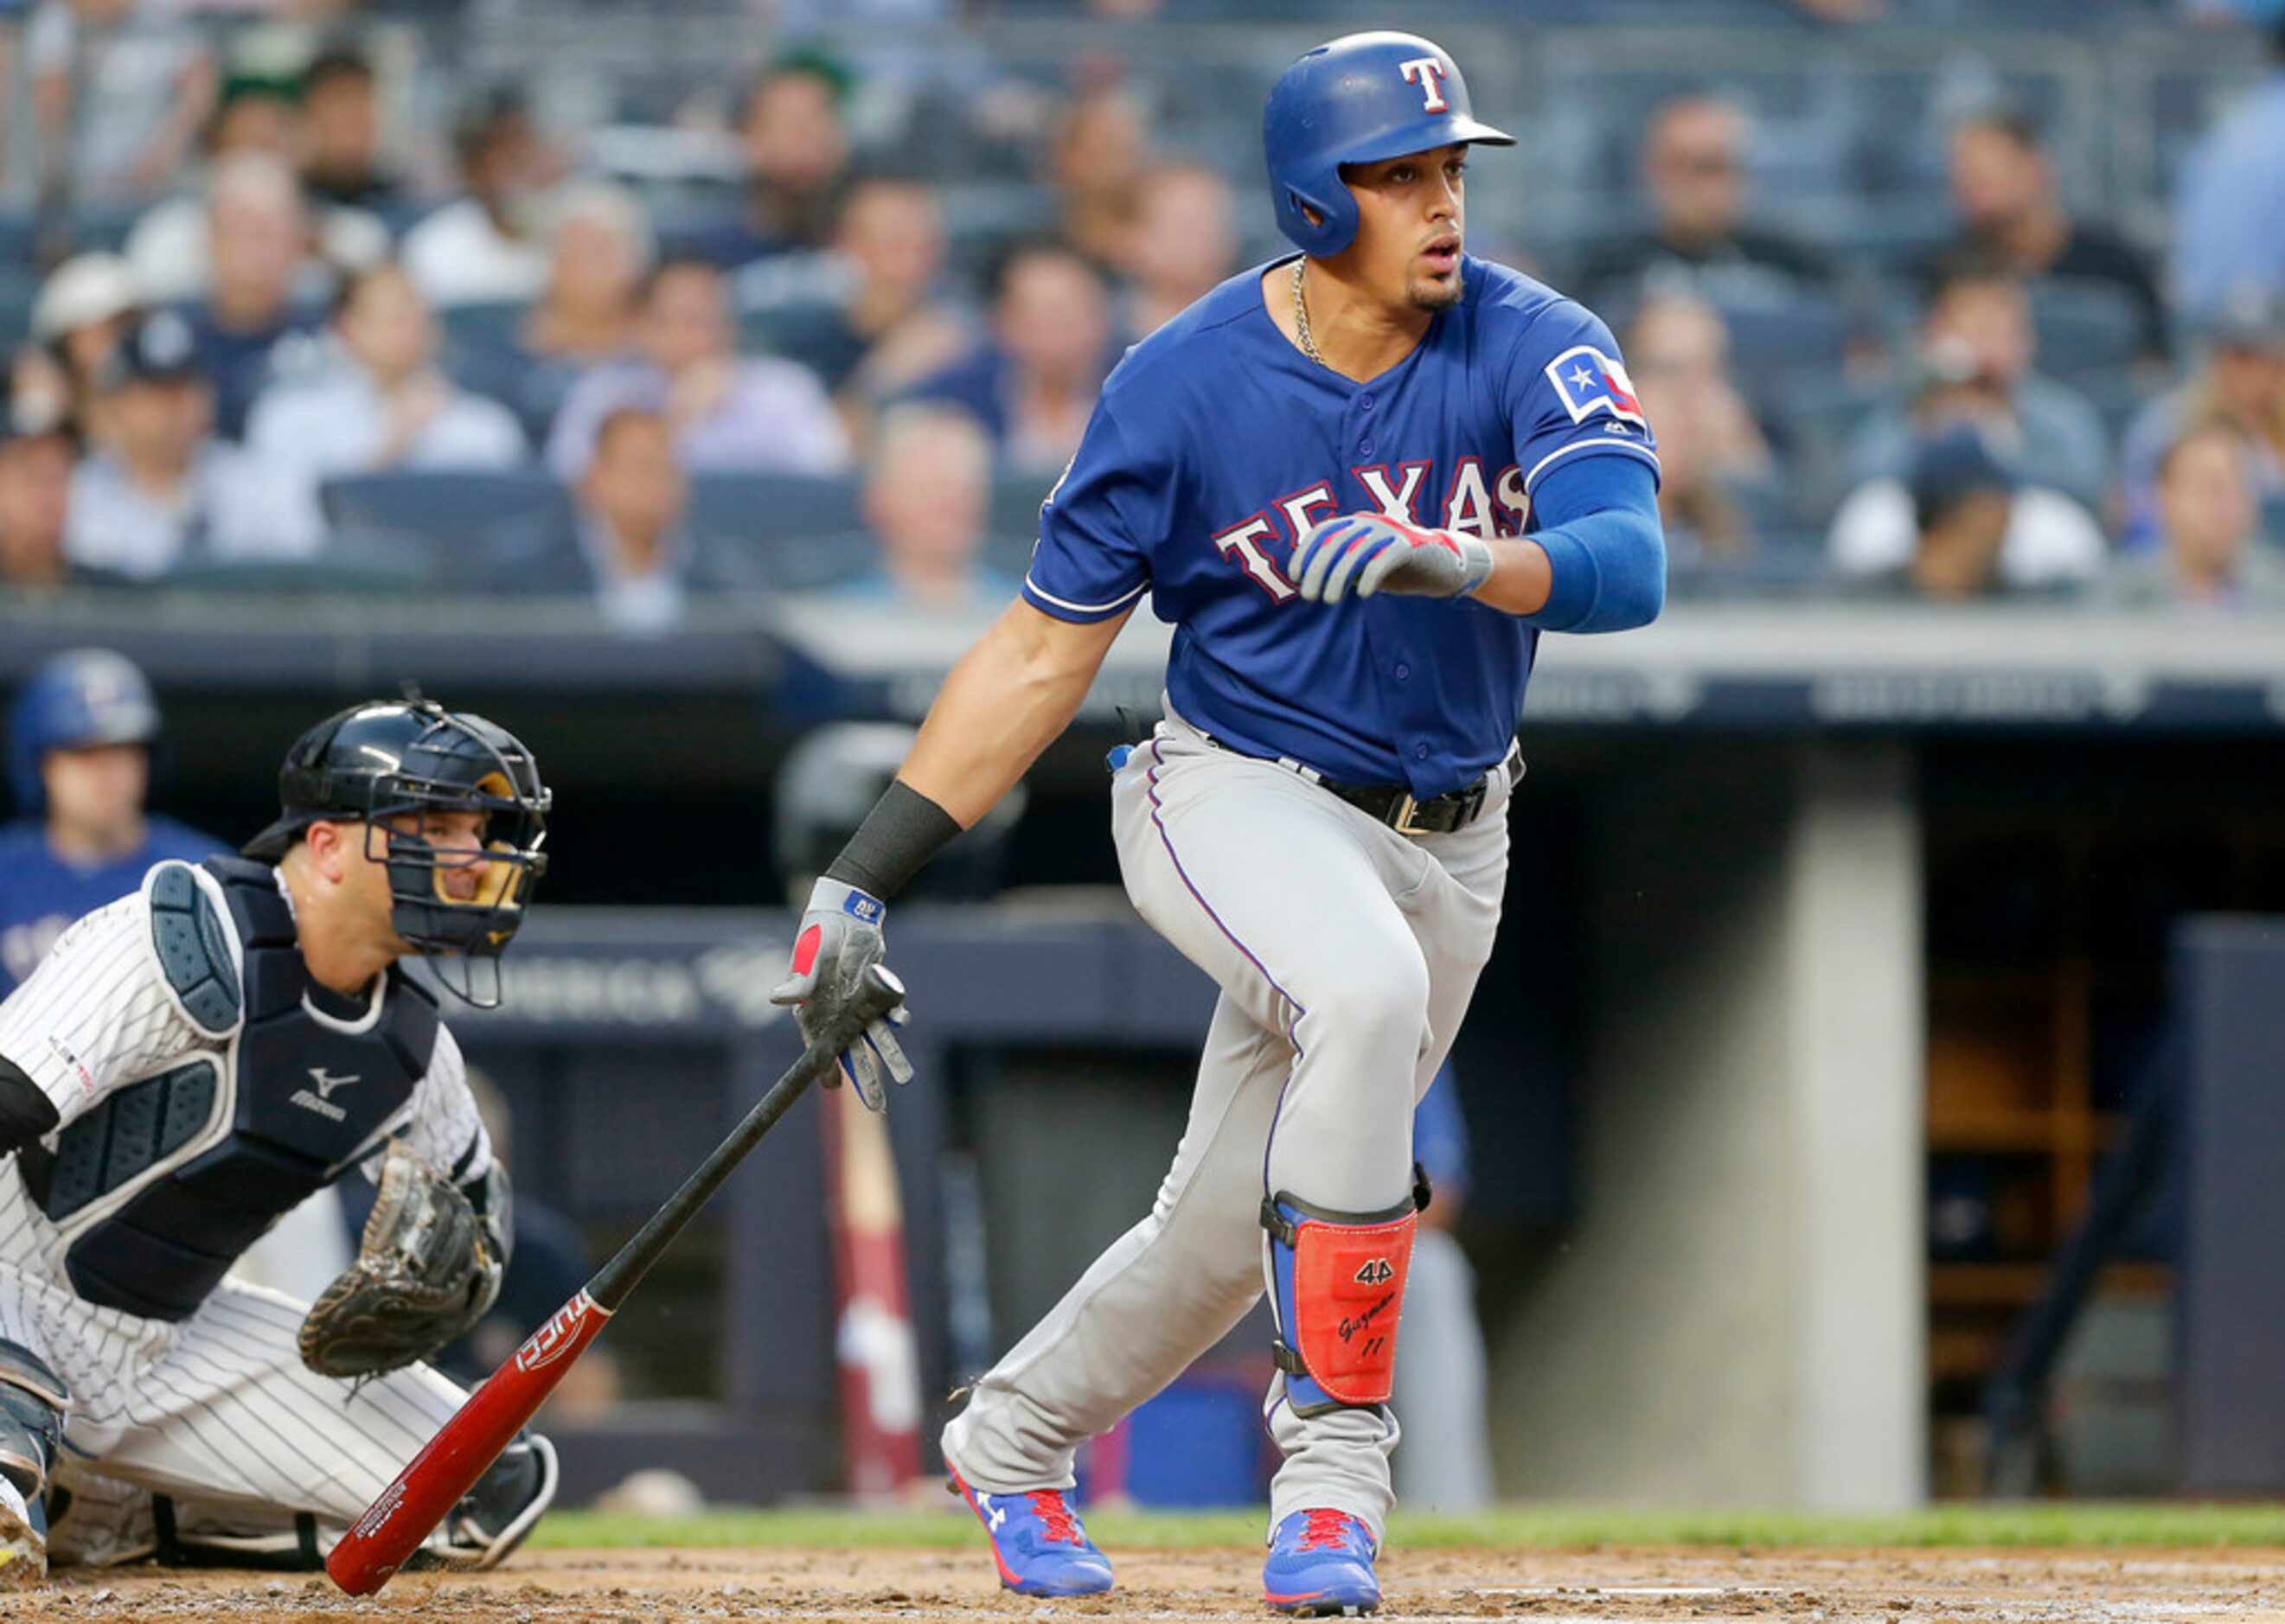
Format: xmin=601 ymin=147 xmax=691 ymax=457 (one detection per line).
xmin=1261 ymin=32 xmax=1515 ymax=258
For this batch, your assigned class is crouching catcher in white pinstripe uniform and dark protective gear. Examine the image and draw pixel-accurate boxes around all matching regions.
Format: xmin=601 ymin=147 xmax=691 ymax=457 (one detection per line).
xmin=0 ymin=699 xmax=555 ymax=1585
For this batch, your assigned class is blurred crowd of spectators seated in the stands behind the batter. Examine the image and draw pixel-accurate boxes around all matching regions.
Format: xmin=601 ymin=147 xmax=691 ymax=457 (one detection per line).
xmin=0 ymin=0 xmax=2285 ymax=633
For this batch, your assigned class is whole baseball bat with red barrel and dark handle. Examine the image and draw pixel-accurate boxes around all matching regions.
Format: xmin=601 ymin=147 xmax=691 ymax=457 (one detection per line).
xmin=324 ymin=964 xmax=905 ymax=1596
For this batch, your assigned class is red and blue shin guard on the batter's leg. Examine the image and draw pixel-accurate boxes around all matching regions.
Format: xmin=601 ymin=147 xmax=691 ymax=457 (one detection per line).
xmin=1261 ymin=1190 xmax=1421 ymax=1416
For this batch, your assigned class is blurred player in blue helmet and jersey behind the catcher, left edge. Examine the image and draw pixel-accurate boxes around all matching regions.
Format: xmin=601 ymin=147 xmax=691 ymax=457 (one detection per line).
xmin=0 ymin=649 xmax=221 ymax=998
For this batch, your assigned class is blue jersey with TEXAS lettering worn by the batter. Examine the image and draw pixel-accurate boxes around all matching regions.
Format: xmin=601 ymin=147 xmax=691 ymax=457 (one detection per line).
xmin=1024 ymin=258 xmax=1656 ymax=799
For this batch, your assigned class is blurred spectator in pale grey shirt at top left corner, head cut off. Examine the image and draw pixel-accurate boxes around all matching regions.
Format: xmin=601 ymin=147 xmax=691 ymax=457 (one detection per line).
xmin=22 ymin=0 xmax=217 ymax=208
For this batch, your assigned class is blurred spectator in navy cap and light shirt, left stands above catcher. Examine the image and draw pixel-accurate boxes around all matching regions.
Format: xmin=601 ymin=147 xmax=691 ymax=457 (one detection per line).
xmin=64 ymin=310 xmax=310 ymax=580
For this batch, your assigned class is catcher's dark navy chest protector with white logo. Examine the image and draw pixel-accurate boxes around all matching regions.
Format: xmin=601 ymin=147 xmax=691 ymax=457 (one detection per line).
xmin=22 ymin=857 xmax=437 ymax=1320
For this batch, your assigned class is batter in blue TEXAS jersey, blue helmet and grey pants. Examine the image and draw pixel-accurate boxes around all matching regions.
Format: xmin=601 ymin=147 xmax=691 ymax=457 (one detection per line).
xmin=775 ymin=32 xmax=1666 ymax=1614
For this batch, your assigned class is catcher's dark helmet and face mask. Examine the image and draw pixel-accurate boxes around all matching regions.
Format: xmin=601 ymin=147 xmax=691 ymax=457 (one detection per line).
xmin=242 ymin=699 xmax=555 ymax=1009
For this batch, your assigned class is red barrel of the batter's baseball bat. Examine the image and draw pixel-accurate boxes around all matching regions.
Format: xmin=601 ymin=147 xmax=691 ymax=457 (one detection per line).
xmin=324 ymin=1290 xmax=610 ymax=1596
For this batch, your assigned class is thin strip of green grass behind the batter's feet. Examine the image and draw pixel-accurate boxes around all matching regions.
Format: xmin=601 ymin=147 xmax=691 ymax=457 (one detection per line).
xmin=533 ymin=1500 xmax=2285 ymax=1550
